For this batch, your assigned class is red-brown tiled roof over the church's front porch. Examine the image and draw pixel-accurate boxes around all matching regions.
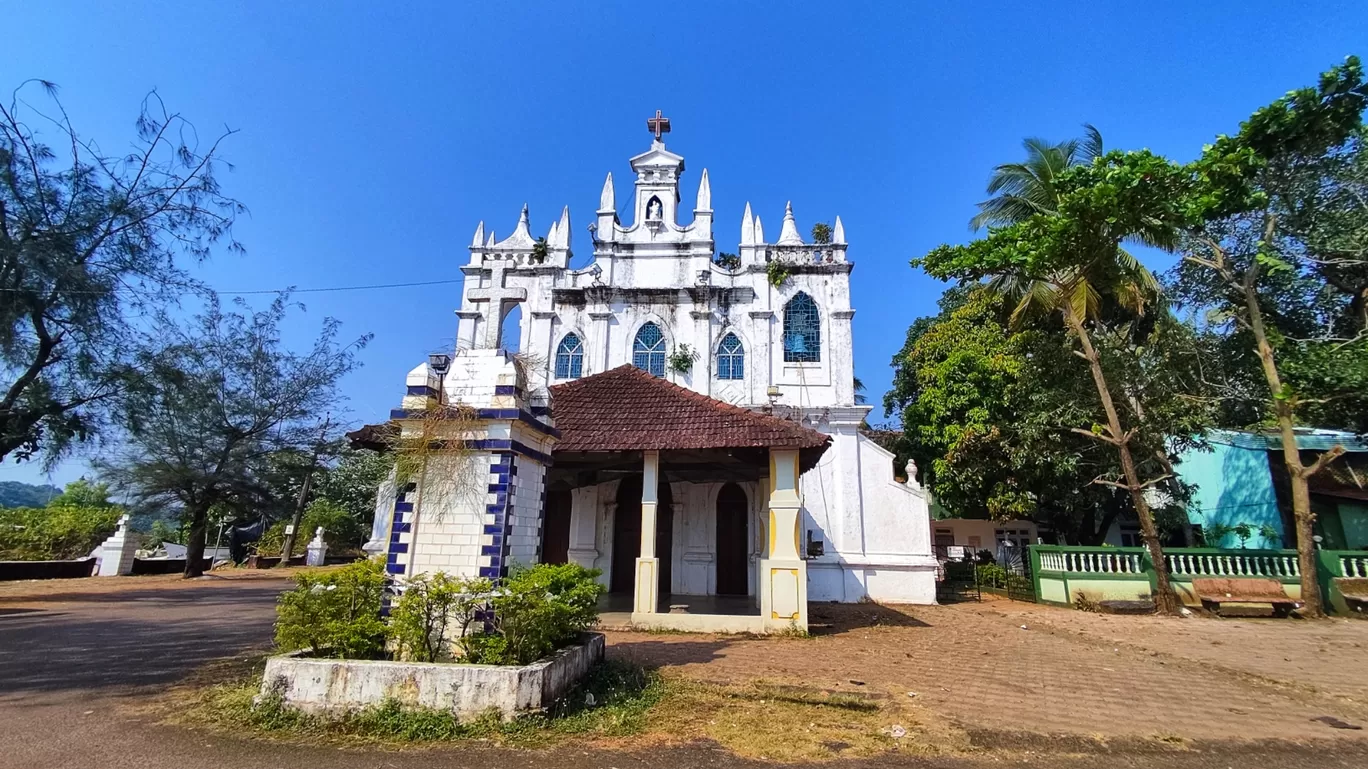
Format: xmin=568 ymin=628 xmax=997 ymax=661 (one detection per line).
xmin=551 ymin=365 xmax=832 ymax=454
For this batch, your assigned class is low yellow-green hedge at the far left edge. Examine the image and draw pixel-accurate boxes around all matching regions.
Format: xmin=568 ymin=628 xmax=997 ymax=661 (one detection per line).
xmin=0 ymin=505 xmax=122 ymax=561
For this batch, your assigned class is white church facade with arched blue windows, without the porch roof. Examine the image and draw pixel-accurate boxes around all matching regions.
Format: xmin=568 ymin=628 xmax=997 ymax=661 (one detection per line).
xmin=437 ymin=116 xmax=936 ymax=603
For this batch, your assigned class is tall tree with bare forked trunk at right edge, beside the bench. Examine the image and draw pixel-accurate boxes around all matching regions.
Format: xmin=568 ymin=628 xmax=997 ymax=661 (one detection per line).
xmin=1175 ymin=56 xmax=1368 ymax=616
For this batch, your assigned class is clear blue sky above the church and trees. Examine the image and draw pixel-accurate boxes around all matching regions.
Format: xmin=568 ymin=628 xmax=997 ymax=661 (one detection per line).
xmin=0 ymin=0 xmax=1368 ymax=483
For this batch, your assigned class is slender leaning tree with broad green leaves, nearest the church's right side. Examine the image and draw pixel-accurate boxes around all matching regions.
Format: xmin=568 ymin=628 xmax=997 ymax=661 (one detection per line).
xmin=912 ymin=152 xmax=1187 ymax=612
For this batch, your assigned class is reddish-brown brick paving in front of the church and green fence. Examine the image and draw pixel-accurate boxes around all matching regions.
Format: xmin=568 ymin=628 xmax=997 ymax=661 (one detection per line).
xmin=609 ymin=601 xmax=1368 ymax=739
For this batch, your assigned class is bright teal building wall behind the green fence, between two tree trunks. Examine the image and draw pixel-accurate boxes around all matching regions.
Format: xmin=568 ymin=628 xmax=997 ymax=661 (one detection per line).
xmin=1176 ymin=436 xmax=1287 ymax=549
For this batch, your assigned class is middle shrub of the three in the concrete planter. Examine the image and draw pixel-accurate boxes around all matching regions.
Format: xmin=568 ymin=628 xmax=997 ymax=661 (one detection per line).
xmin=390 ymin=572 xmax=494 ymax=662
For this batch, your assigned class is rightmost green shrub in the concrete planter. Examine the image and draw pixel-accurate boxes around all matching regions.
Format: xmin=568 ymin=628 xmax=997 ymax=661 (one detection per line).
xmin=481 ymin=564 xmax=605 ymax=665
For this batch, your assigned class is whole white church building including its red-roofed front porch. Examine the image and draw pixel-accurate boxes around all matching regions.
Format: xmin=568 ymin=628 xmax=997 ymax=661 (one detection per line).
xmin=363 ymin=114 xmax=936 ymax=624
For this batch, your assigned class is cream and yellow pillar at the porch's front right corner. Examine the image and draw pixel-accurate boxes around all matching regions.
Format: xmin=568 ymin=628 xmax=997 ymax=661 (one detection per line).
xmin=759 ymin=449 xmax=807 ymax=631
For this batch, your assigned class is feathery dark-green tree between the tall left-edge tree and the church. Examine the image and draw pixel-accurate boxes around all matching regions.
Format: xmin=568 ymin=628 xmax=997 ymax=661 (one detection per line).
xmin=101 ymin=296 xmax=369 ymax=577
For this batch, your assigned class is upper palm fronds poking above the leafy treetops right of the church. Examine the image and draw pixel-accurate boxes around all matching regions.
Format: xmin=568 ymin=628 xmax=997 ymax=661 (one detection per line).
xmin=969 ymin=123 xmax=1103 ymax=230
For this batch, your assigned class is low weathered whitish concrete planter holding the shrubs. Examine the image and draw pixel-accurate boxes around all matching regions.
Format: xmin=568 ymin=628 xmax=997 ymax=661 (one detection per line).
xmin=261 ymin=634 xmax=603 ymax=717
